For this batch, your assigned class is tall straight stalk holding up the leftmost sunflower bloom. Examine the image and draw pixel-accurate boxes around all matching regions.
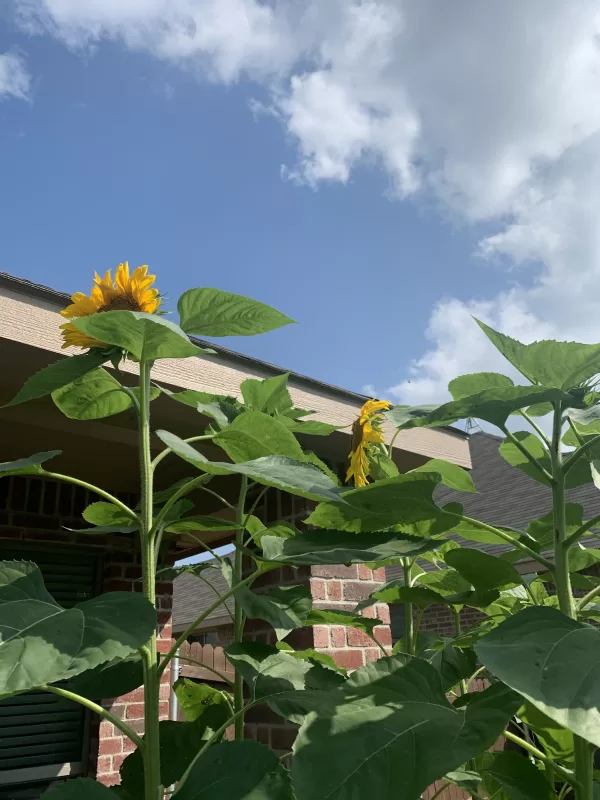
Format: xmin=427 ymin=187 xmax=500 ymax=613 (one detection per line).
xmin=139 ymin=361 xmax=162 ymax=800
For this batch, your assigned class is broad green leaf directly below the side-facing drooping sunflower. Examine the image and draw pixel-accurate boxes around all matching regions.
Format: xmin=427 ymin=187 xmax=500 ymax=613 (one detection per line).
xmin=307 ymin=472 xmax=456 ymax=535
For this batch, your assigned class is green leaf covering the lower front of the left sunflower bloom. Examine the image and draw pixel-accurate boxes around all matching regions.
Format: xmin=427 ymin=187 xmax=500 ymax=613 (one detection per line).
xmin=73 ymin=311 xmax=203 ymax=361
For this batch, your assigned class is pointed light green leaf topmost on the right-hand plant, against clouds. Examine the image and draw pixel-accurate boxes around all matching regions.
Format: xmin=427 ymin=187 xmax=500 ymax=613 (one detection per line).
xmin=475 ymin=320 xmax=600 ymax=389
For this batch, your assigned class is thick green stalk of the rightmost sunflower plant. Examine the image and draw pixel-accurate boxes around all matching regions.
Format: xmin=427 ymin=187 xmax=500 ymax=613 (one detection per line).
xmin=550 ymin=403 xmax=594 ymax=800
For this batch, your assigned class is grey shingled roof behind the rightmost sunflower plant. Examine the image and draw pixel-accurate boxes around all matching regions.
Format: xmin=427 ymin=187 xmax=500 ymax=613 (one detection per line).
xmin=386 ymin=431 xmax=600 ymax=580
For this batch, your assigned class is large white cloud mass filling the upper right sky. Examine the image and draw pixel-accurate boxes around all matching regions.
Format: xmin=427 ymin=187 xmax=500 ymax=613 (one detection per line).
xmin=14 ymin=0 xmax=600 ymax=402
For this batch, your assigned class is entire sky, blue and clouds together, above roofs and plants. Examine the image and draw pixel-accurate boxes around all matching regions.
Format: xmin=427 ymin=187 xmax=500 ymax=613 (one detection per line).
xmin=0 ymin=0 xmax=600 ymax=402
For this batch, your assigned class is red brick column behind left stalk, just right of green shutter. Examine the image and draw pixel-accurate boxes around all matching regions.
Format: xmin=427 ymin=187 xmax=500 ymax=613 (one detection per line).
xmin=91 ymin=550 xmax=173 ymax=786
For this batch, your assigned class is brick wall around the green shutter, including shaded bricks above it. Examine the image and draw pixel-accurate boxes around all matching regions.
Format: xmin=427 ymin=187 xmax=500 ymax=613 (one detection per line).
xmin=0 ymin=476 xmax=172 ymax=785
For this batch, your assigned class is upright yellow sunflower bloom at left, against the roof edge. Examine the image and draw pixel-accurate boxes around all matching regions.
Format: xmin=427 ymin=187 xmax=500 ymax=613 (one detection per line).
xmin=60 ymin=261 xmax=160 ymax=349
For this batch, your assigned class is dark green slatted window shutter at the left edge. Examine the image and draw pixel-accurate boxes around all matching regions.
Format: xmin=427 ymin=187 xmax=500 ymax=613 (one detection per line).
xmin=0 ymin=546 xmax=98 ymax=800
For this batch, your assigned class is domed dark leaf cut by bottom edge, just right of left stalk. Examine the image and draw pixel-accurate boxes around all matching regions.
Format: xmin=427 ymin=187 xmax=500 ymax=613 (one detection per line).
xmin=172 ymin=741 xmax=292 ymax=800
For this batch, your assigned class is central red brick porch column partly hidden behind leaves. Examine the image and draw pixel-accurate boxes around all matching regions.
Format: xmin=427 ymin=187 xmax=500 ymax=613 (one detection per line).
xmin=246 ymin=564 xmax=392 ymax=753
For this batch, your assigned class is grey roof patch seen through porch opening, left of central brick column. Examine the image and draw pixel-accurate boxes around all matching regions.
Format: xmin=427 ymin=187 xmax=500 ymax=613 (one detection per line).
xmin=173 ymin=556 xmax=233 ymax=634
